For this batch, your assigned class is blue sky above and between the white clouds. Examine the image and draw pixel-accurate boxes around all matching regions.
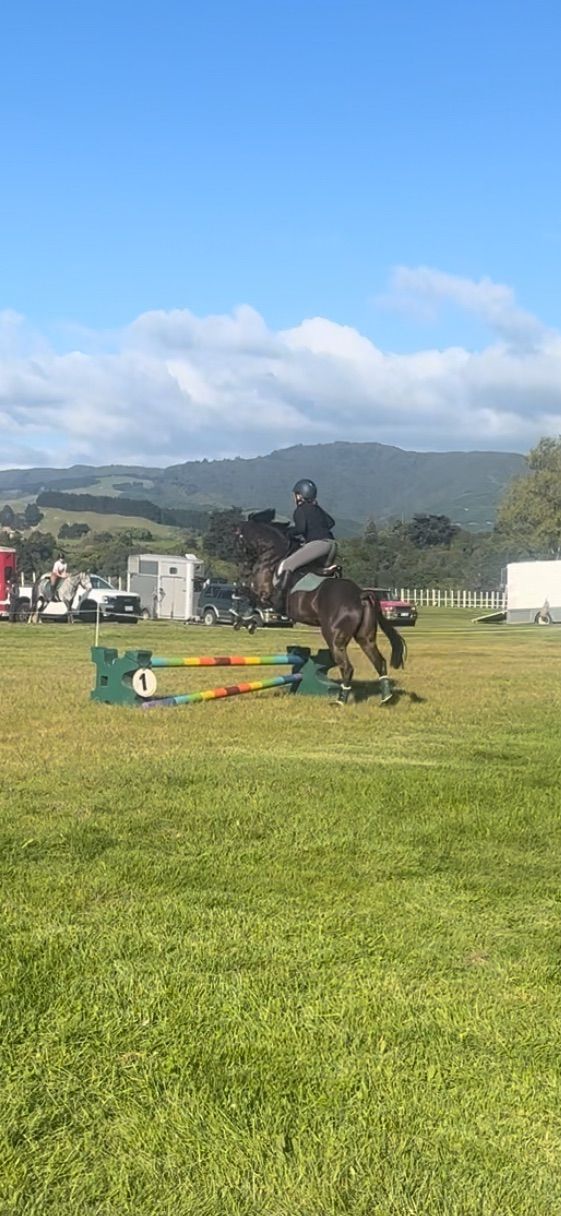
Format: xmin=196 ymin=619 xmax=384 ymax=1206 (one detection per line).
xmin=0 ymin=0 xmax=561 ymax=460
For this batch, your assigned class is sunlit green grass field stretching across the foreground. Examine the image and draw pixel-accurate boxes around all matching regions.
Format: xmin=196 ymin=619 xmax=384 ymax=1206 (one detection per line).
xmin=0 ymin=612 xmax=561 ymax=1216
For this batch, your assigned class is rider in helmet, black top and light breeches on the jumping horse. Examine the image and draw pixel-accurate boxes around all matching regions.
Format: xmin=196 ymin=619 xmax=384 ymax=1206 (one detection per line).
xmin=273 ymin=477 xmax=337 ymax=613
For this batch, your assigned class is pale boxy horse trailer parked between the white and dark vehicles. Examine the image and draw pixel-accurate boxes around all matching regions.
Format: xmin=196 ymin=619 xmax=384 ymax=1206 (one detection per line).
xmin=127 ymin=553 xmax=203 ymax=621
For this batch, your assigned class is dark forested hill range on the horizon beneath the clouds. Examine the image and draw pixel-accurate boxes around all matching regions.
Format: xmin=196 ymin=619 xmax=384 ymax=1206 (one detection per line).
xmin=0 ymin=443 xmax=526 ymax=535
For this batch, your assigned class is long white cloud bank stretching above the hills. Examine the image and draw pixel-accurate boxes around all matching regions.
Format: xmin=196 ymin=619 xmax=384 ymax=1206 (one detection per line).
xmin=0 ymin=273 xmax=561 ymax=467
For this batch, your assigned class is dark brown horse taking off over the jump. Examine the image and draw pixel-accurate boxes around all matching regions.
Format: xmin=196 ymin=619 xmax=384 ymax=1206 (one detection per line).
xmin=237 ymin=519 xmax=406 ymax=705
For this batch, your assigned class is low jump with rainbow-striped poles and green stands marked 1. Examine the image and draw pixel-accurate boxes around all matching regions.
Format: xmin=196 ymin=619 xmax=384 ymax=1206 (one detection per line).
xmin=90 ymin=646 xmax=338 ymax=709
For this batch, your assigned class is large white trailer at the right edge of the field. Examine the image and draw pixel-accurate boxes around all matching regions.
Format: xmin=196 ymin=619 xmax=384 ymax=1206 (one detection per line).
xmin=506 ymin=558 xmax=561 ymax=625
